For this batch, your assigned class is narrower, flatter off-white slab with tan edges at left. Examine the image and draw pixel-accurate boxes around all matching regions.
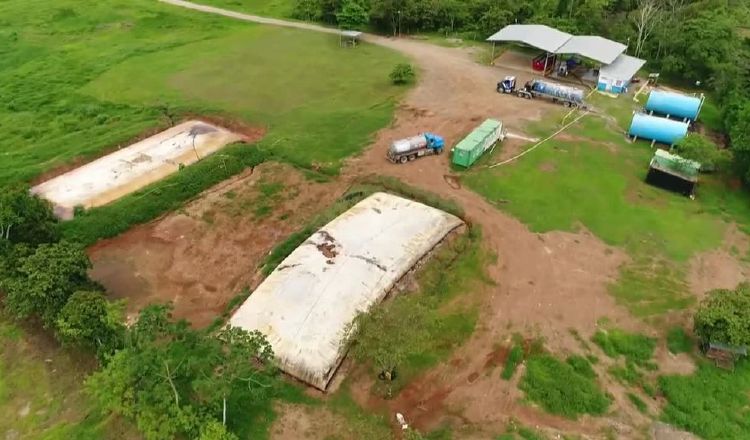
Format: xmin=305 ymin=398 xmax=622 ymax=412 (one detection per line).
xmin=31 ymin=121 xmax=241 ymax=219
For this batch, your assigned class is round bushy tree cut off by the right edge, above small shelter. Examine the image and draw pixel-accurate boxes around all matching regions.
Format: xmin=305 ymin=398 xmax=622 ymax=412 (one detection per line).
xmin=694 ymin=283 xmax=750 ymax=346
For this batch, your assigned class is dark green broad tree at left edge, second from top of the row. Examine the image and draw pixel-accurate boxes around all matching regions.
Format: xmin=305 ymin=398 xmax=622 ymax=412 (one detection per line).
xmin=3 ymin=241 xmax=91 ymax=328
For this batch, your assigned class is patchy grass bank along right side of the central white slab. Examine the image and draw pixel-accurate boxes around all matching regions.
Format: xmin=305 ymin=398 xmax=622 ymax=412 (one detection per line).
xmin=352 ymin=228 xmax=490 ymax=396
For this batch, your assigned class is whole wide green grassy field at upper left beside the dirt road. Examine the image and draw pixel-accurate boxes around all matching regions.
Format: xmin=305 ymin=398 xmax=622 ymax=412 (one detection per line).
xmin=0 ymin=0 xmax=403 ymax=185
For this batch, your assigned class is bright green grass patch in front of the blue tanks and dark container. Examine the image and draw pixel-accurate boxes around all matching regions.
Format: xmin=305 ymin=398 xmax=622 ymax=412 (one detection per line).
xmin=463 ymin=122 xmax=726 ymax=260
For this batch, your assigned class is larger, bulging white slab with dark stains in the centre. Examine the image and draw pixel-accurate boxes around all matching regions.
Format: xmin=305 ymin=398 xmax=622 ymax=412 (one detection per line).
xmin=230 ymin=193 xmax=462 ymax=390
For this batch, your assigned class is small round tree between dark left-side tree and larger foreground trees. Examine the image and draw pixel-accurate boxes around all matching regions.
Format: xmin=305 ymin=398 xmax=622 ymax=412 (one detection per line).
xmin=57 ymin=291 xmax=125 ymax=358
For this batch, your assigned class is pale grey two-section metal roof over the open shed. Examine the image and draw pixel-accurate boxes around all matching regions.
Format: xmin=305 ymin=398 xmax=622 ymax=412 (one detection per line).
xmin=487 ymin=24 xmax=627 ymax=64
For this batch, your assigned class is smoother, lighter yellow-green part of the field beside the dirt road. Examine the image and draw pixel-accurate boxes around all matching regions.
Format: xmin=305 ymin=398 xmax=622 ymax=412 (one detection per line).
xmin=82 ymin=23 xmax=405 ymax=173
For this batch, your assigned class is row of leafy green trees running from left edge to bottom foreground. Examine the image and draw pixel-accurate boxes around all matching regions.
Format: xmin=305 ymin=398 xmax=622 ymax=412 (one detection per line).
xmin=0 ymin=187 xmax=279 ymax=440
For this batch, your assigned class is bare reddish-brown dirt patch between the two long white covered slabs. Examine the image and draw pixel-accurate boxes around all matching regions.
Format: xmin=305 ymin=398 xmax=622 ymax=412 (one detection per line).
xmin=89 ymin=164 xmax=343 ymax=327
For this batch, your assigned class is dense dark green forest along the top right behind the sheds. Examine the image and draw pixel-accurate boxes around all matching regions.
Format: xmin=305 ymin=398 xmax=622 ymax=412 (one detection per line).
xmin=295 ymin=0 xmax=750 ymax=181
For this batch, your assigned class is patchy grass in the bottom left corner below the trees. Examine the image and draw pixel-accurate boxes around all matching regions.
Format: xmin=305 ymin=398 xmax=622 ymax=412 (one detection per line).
xmin=0 ymin=315 xmax=136 ymax=440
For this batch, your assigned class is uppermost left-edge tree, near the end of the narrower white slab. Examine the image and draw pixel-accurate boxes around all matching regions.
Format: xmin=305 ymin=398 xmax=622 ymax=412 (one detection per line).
xmin=0 ymin=186 xmax=58 ymax=246
